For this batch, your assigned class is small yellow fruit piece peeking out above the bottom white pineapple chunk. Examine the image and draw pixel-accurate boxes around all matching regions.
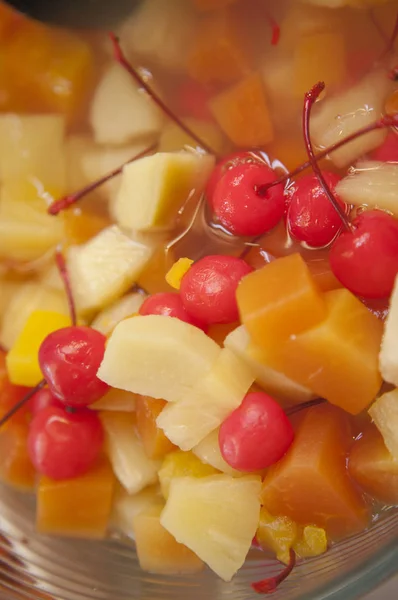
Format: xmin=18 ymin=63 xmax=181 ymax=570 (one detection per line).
xmin=159 ymin=450 xmax=218 ymax=500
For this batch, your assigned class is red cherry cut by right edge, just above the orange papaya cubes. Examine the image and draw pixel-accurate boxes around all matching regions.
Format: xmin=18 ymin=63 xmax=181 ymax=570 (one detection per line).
xmin=330 ymin=210 xmax=398 ymax=298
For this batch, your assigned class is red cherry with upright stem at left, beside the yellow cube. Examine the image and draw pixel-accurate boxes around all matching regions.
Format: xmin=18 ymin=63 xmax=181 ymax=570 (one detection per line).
xmin=39 ymin=327 xmax=108 ymax=407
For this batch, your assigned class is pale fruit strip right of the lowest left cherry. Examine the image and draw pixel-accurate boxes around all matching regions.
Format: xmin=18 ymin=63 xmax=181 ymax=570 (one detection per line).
xmin=101 ymin=412 xmax=158 ymax=494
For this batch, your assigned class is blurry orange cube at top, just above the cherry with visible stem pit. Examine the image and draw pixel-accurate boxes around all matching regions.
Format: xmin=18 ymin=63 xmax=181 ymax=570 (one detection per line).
xmin=210 ymin=74 xmax=274 ymax=148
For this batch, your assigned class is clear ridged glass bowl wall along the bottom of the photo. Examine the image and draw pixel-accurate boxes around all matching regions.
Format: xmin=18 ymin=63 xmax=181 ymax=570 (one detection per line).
xmin=0 ymin=486 xmax=398 ymax=600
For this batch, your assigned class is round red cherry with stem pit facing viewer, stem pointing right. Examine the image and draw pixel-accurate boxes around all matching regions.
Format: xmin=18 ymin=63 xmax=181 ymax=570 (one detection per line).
xmin=213 ymin=163 xmax=285 ymax=236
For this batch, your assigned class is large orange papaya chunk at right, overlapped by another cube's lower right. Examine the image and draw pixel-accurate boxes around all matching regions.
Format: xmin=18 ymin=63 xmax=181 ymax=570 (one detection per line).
xmin=279 ymin=289 xmax=383 ymax=415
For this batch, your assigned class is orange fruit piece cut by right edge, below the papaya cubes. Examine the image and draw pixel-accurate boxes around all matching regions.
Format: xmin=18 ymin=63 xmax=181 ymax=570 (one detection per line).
xmin=348 ymin=424 xmax=398 ymax=504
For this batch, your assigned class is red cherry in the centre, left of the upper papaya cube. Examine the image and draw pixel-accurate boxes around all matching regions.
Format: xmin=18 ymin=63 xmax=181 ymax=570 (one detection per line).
xmin=180 ymin=255 xmax=253 ymax=325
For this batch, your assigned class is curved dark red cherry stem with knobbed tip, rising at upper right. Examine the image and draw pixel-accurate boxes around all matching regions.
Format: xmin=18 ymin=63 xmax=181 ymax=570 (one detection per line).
xmin=303 ymin=81 xmax=351 ymax=231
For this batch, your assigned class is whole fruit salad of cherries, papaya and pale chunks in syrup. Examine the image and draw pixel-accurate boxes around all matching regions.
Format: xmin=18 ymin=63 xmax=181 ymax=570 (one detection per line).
xmin=0 ymin=0 xmax=398 ymax=593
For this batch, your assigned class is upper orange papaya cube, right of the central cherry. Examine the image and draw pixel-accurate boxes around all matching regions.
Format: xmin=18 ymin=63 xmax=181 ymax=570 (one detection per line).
xmin=237 ymin=254 xmax=326 ymax=352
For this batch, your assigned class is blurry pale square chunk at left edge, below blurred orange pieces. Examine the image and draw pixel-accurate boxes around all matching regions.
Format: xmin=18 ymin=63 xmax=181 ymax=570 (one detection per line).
xmin=0 ymin=114 xmax=66 ymax=188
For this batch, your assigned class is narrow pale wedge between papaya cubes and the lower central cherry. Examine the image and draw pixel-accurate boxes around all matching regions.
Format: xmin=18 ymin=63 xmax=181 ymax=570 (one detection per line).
xmin=224 ymin=325 xmax=313 ymax=404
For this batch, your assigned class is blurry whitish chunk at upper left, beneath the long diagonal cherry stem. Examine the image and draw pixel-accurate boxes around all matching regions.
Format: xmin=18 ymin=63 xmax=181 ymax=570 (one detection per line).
xmin=90 ymin=63 xmax=163 ymax=146
